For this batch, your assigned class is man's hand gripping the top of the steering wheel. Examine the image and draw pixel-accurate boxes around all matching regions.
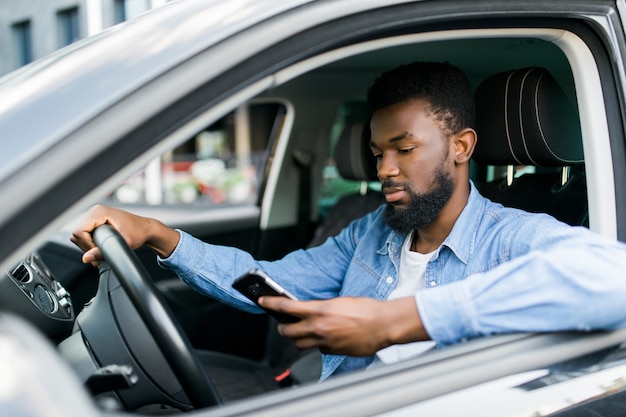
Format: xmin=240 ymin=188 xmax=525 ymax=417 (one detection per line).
xmin=71 ymin=205 xmax=180 ymax=265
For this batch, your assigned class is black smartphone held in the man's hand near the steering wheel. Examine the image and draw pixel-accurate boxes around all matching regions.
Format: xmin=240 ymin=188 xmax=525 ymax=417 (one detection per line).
xmin=233 ymin=268 xmax=300 ymax=323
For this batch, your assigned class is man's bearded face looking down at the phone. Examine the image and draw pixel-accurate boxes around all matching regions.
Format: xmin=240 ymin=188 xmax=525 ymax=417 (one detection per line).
xmin=371 ymin=101 xmax=454 ymax=232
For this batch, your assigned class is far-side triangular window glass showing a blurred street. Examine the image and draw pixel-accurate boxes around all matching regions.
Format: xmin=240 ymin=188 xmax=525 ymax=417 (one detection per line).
xmin=108 ymin=103 xmax=286 ymax=207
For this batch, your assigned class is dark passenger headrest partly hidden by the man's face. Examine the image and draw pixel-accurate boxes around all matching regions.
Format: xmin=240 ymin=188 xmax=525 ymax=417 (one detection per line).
xmin=334 ymin=122 xmax=378 ymax=181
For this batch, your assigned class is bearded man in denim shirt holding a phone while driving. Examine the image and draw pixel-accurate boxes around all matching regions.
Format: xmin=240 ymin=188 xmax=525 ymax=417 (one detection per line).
xmin=72 ymin=63 xmax=626 ymax=379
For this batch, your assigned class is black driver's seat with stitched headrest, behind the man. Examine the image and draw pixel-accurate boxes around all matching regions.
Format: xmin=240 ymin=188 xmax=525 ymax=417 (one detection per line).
xmin=473 ymin=67 xmax=588 ymax=225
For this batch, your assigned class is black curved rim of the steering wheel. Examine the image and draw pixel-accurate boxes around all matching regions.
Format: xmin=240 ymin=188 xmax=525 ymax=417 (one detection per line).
xmin=93 ymin=225 xmax=221 ymax=408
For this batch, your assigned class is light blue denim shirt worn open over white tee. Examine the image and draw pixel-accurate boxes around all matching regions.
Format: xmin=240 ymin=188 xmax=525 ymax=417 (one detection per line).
xmin=160 ymin=184 xmax=626 ymax=379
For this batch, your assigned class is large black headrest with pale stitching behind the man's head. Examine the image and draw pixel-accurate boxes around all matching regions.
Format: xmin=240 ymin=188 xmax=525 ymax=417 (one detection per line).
xmin=474 ymin=67 xmax=583 ymax=166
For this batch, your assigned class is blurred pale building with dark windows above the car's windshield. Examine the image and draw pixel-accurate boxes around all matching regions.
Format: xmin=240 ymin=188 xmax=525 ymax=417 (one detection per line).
xmin=0 ymin=0 xmax=168 ymax=76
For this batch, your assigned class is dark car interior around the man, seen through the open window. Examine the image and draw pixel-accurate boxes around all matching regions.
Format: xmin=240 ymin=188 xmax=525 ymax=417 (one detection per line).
xmin=0 ymin=13 xmax=616 ymax=413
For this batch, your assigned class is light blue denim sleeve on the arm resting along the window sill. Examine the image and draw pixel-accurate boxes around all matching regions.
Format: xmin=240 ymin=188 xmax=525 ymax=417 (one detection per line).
xmin=415 ymin=242 xmax=626 ymax=345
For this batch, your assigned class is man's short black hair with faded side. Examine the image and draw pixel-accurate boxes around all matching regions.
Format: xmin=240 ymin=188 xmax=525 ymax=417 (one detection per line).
xmin=367 ymin=62 xmax=476 ymax=136
